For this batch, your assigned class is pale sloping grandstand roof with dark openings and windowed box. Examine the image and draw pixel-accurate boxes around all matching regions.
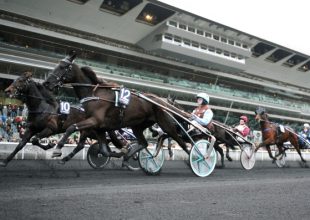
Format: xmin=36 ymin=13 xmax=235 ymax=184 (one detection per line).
xmin=0 ymin=0 xmax=310 ymax=88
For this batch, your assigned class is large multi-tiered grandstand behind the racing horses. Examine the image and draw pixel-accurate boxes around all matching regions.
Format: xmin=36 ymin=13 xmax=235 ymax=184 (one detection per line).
xmin=0 ymin=0 xmax=310 ymax=131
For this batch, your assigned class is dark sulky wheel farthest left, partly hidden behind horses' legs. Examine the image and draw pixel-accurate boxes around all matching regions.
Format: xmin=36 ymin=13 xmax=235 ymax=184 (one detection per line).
xmin=87 ymin=143 xmax=110 ymax=169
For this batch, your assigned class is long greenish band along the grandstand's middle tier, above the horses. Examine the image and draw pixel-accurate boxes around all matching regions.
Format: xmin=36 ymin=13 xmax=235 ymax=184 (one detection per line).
xmin=0 ymin=42 xmax=310 ymax=114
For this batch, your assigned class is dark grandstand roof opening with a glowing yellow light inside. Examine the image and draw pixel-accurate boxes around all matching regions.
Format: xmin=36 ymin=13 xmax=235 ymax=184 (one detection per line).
xmin=136 ymin=3 xmax=175 ymax=26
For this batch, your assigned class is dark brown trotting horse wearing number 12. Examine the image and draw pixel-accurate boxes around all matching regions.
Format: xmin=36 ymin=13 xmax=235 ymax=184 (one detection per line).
xmin=44 ymin=52 xmax=194 ymax=162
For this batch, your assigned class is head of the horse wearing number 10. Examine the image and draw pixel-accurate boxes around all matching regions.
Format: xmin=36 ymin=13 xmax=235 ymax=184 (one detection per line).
xmin=4 ymin=72 xmax=32 ymax=98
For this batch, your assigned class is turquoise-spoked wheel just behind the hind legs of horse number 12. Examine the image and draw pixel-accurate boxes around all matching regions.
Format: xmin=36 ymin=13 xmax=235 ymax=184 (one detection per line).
xmin=139 ymin=141 xmax=165 ymax=175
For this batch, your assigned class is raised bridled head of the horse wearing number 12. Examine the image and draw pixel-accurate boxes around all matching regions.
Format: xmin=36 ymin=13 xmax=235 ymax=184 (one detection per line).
xmin=43 ymin=51 xmax=77 ymax=91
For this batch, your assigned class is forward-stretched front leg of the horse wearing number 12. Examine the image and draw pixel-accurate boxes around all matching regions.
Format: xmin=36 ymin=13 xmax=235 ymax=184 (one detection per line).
xmin=52 ymin=117 xmax=97 ymax=157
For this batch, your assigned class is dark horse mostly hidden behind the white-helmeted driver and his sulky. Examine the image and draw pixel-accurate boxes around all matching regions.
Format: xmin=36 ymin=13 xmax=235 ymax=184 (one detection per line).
xmin=167 ymin=95 xmax=249 ymax=168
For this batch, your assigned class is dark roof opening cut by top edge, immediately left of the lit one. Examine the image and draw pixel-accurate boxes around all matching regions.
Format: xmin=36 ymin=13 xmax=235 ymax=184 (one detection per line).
xmin=100 ymin=0 xmax=142 ymax=15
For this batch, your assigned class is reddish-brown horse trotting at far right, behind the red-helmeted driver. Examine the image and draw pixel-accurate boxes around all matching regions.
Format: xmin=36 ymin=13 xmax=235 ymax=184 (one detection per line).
xmin=255 ymin=107 xmax=306 ymax=166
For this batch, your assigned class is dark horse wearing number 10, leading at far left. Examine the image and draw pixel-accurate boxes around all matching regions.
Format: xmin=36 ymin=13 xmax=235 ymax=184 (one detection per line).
xmin=0 ymin=72 xmax=122 ymax=166
